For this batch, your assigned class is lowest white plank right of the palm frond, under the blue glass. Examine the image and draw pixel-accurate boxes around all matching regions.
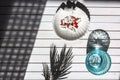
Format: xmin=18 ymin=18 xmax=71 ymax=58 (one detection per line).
xmin=67 ymin=72 xmax=119 ymax=80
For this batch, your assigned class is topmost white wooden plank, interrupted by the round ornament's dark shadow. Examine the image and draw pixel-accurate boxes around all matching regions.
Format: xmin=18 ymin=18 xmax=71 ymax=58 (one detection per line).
xmin=46 ymin=0 xmax=120 ymax=7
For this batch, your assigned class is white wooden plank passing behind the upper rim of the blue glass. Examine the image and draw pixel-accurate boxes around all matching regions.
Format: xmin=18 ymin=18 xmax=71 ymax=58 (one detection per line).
xmin=32 ymin=48 xmax=120 ymax=56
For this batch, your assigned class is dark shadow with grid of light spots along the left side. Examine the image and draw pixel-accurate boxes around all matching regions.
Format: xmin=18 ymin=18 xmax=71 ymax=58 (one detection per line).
xmin=0 ymin=0 xmax=47 ymax=80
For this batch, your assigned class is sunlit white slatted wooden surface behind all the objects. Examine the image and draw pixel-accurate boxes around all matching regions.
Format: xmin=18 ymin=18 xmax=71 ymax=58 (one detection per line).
xmin=25 ymin=0 xmax=120 ymax=80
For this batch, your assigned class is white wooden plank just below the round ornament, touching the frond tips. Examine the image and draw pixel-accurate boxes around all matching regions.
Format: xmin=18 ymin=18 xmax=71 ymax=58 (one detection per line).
xmin=34 ymin=39 xmax=120 ymax=47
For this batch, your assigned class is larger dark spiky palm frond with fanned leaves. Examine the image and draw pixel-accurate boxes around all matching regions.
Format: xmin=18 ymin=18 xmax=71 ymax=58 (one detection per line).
xmin=50 ymin=45 xmax=73 ymax=80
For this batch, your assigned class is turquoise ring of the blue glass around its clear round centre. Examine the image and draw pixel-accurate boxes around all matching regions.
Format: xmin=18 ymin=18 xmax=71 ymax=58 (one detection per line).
xmin=85 ymin=49 xmax=111 ymax=75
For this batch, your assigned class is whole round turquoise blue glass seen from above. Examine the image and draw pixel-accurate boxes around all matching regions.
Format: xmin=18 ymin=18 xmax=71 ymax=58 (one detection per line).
xmin=85 ymin=49 xmax=111 ymax=75
